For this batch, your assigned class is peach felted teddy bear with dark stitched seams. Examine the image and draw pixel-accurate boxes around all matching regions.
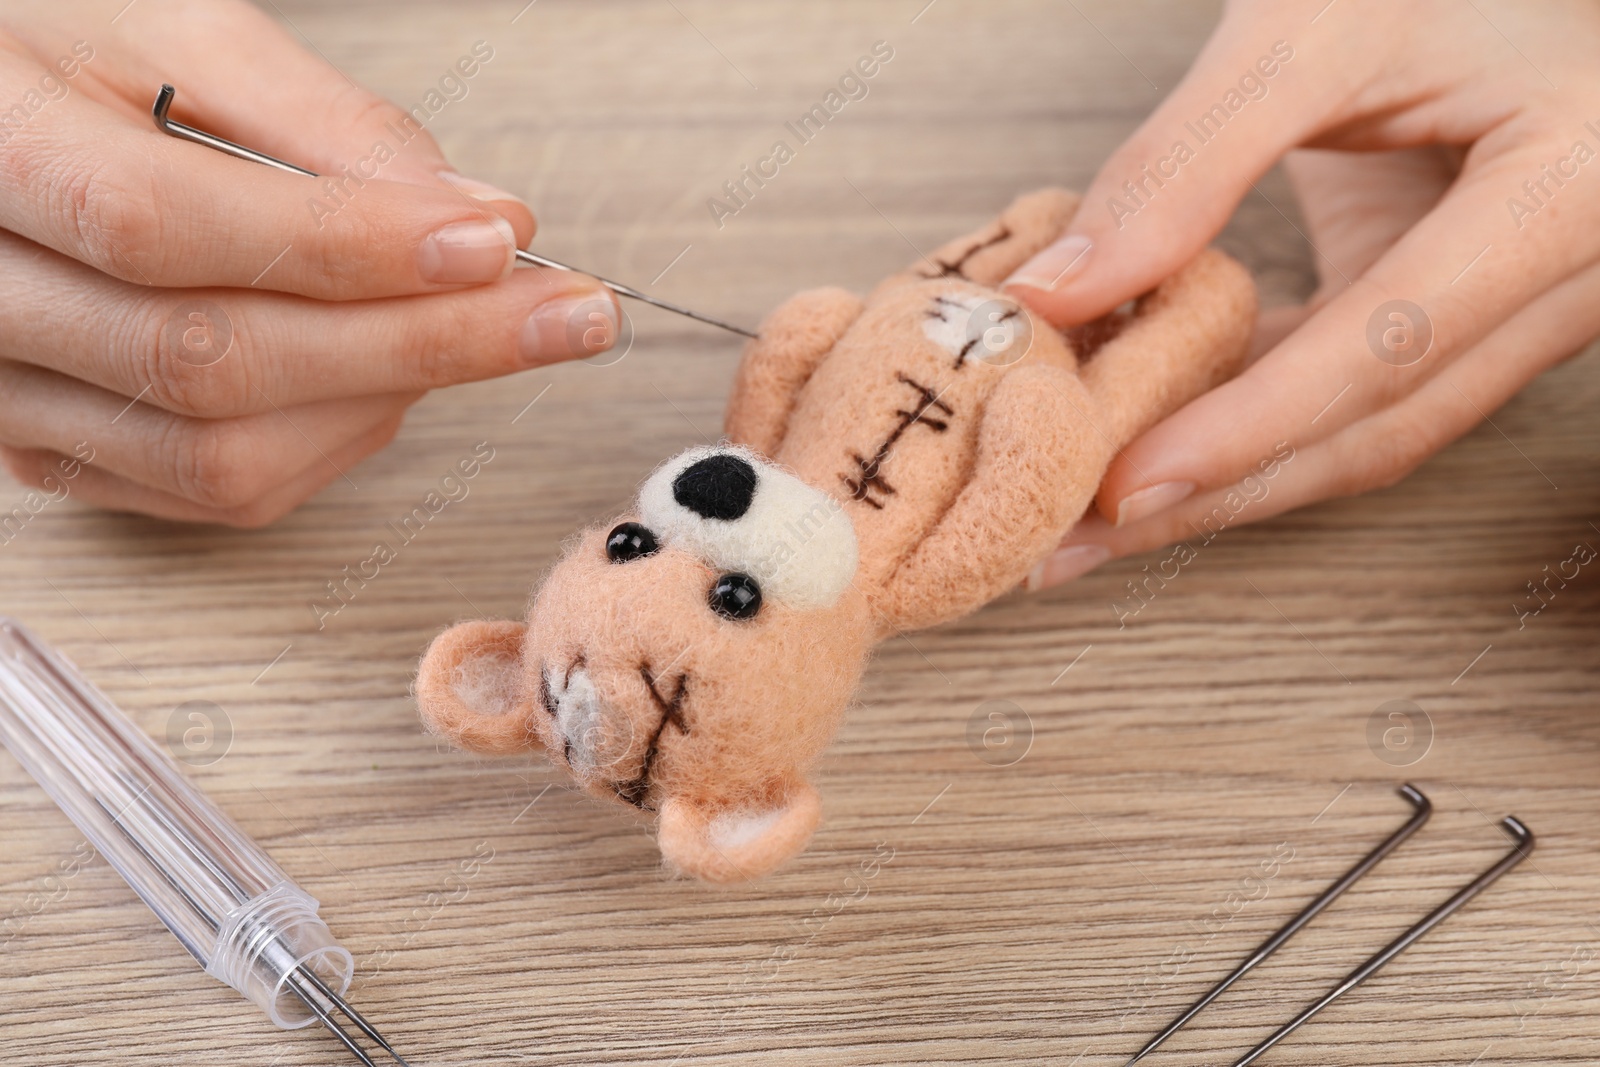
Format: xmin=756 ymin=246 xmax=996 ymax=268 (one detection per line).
xmin=416 ymin=189 xmax=1256 ymax=883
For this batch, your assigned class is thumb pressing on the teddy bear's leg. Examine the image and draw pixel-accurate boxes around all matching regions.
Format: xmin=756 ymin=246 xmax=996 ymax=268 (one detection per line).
xmin=1003 ymin=24 xmax=1325 ymax=326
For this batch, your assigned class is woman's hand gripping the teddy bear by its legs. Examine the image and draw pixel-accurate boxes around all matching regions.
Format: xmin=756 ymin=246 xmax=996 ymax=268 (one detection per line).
xmin=1008 ymin=0 xmax=1600 ymax=589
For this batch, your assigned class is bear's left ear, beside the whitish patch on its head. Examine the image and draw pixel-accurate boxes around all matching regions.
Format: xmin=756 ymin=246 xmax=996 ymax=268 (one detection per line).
xmin=416 ymin=619 xmax=539 ymax=755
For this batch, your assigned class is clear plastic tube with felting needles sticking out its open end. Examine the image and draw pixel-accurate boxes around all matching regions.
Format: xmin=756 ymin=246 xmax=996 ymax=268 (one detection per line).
xmin=0 ymin=617 xmax=405 ymax=1067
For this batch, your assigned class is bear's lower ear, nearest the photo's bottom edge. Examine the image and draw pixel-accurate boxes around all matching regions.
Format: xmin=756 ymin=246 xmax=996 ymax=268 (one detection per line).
xmin=658 ymin=781 xmax=822 ymax=885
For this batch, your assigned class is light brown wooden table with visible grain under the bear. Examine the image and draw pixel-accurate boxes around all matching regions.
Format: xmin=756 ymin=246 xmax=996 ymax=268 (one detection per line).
xmin=0 ymin=0 xmax=1600 ymax=1067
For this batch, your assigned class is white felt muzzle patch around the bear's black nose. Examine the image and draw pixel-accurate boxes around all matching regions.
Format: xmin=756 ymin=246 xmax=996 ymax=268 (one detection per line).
xmin=638 ymin=445 xmax=858 ymax=611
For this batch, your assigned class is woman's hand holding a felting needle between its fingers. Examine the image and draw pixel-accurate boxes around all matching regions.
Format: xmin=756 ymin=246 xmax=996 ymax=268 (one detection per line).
xmin=0 ymin=0 xmax=618 ymax=526
